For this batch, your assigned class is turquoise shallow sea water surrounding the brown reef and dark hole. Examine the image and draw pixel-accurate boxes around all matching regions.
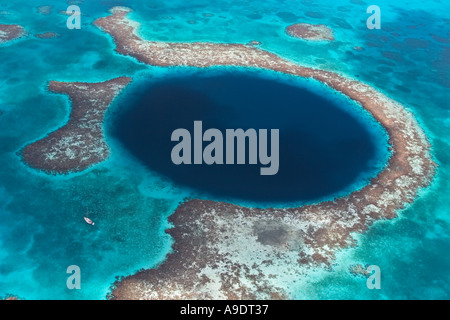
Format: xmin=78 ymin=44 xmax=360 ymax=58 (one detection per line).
xmin=0 ymin=0 xmax=450 ymax=299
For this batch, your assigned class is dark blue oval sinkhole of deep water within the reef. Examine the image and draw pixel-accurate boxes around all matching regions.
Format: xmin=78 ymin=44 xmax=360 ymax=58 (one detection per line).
xmin=109 ymin=73 xmax=383 ymax=203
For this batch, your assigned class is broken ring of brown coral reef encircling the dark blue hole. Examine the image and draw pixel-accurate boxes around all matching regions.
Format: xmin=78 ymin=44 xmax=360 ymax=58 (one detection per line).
xmin=23 ymin=7 xmax=436 ymax=299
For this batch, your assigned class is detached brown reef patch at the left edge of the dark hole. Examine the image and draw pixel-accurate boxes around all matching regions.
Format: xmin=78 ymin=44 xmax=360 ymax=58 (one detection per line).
xmin=22 ymin=77 xmax=131 ymax=174
